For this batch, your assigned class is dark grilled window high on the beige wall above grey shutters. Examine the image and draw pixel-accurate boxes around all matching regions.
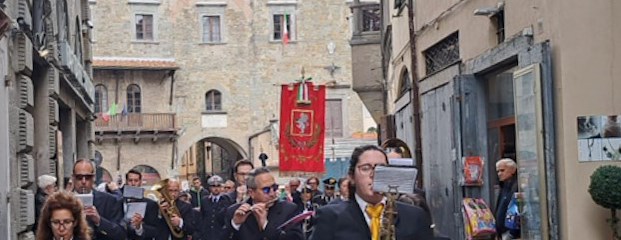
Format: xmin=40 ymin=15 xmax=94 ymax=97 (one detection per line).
xmin=423 ymin=32 xmax=459 ymax=74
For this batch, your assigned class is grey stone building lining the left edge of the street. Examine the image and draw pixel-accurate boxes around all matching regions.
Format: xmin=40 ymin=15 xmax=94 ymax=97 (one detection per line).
xmin=0 ymin=0 xmax=94 ymax=239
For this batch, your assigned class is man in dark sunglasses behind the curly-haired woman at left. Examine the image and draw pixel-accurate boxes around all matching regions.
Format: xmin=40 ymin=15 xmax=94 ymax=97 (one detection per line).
xmin=73 ymin=159 xmax=127 ymax=240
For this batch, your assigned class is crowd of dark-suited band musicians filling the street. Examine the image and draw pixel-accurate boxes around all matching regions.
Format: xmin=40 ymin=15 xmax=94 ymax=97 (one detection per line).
xmin=36 ymin=142 xmax=520 ymax=240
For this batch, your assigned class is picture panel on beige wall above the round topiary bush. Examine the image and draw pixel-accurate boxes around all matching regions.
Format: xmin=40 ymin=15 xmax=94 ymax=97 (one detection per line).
xmin=578 ymin=115 xmax=621 ymax=162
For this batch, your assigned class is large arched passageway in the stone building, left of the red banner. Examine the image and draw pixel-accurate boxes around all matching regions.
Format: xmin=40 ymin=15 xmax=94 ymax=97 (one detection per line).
xmin=180 ymin=137 xmax=245 ymax=185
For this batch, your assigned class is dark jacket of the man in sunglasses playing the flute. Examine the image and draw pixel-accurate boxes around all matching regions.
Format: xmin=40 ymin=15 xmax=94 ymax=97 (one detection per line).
xmin=223 ymin=200 xmax=305 ymax=240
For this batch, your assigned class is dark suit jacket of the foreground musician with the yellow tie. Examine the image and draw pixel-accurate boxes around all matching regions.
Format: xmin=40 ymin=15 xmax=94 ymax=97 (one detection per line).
xmin=310 ymin=200 xmax=433 ymax=240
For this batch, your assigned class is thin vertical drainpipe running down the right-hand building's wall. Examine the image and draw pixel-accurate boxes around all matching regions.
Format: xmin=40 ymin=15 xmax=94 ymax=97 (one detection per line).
xmin=407 ymin=0 xmax=425 ymax=189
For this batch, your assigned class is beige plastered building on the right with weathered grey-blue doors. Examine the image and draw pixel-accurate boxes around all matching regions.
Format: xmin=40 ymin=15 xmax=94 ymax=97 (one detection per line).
xmin=354 ymin=0 xmax=621 ymax=239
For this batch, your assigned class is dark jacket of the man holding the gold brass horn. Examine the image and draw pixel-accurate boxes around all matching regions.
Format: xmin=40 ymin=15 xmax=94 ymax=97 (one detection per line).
xmin=155 ymin=200 xmax=199 ymax=240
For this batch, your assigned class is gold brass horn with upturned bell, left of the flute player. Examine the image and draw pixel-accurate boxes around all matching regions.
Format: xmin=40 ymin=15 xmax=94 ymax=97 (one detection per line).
xmin=151 ymin=179 xmax=185 ymax=239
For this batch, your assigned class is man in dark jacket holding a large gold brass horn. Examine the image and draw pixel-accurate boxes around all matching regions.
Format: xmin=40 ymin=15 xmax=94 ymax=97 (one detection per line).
xmin=158 ymin=179 xmax=198 ymax=240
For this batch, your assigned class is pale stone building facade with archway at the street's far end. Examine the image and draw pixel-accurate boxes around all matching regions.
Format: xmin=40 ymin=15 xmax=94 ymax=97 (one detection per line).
xmin=90 ymin=0 xmax=366 ymax=184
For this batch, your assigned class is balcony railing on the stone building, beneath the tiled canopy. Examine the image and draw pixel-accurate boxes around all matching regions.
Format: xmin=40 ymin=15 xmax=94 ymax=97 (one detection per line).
xmin=95 ymin=113 xmax=175 ymax=132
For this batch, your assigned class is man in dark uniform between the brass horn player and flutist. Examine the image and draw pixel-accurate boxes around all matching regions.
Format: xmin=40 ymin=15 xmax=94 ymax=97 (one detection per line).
xmin=192 ymin=175 xmax=233 ymax=240
